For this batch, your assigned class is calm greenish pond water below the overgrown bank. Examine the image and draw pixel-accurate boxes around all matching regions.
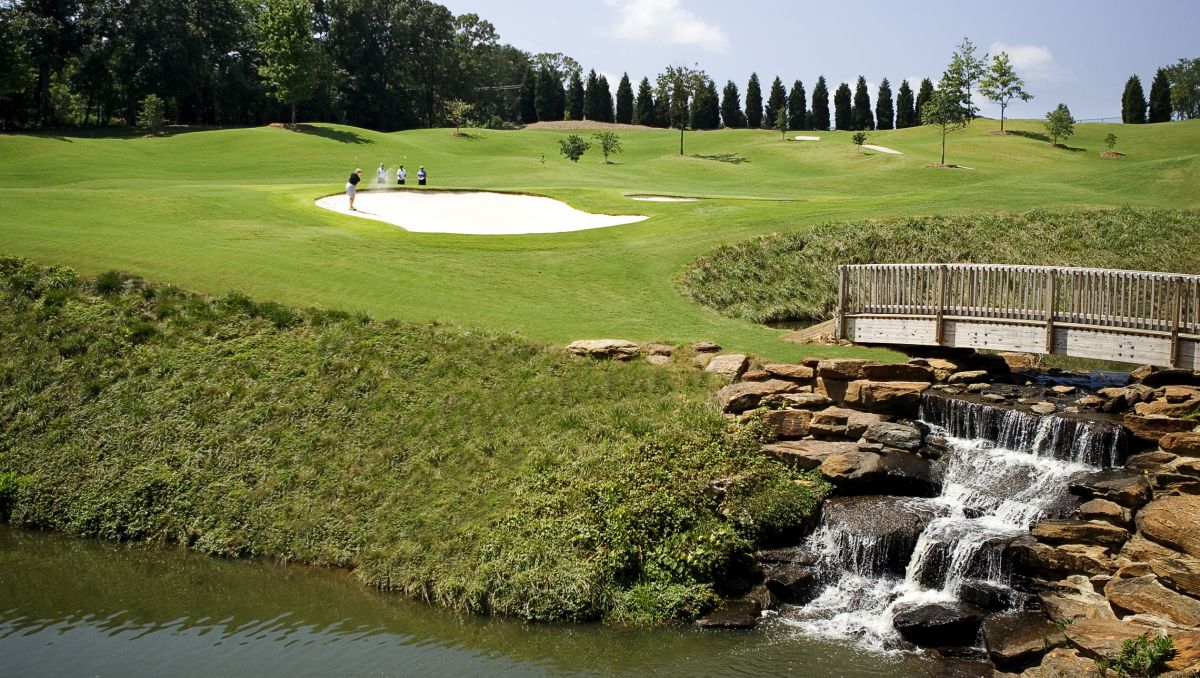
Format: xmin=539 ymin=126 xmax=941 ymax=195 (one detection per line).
xmin=0 ymin=526 xmax=955 ymax=678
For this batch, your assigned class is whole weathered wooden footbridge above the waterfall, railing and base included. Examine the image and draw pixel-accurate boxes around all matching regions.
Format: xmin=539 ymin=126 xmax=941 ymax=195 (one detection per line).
xmin=835 ymin=264 xmax=1200 ymax=370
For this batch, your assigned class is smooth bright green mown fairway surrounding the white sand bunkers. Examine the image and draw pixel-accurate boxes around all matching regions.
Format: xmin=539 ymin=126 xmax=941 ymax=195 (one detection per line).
xmin=0 ymin=120 xmax=1200 ymax=360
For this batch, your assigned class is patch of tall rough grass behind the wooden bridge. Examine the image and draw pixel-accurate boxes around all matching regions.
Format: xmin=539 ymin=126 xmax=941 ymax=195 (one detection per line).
xmin=679 ymin=208 xmax=1200 ymax=323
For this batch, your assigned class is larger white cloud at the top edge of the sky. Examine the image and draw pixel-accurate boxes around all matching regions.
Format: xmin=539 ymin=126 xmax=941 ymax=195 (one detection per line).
xmin=605 ymin=0 xmax=730 ymax=53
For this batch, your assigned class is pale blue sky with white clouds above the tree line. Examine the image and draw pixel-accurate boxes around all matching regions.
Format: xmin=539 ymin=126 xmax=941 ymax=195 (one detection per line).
xmin=439 ymin=0 xmax=1200 ymax=121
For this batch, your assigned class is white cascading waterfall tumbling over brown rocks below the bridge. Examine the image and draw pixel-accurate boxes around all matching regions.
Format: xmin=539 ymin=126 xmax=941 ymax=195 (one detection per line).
xmin=782 ymin=395 xmax=1126 ymax=650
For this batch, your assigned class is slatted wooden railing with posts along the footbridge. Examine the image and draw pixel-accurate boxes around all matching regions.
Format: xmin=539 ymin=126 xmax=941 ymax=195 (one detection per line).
xmin=838 ymin=264 xmax=1200 ymax=364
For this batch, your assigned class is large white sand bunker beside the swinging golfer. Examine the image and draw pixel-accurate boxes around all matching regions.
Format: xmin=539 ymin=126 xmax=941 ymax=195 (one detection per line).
xmin=317 ymin=188 xmax=647 ymax=235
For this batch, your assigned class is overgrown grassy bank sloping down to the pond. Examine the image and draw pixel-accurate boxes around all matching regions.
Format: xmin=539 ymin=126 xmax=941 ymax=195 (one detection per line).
xmin=0 ymin=258 xmax=827 ymax=623
